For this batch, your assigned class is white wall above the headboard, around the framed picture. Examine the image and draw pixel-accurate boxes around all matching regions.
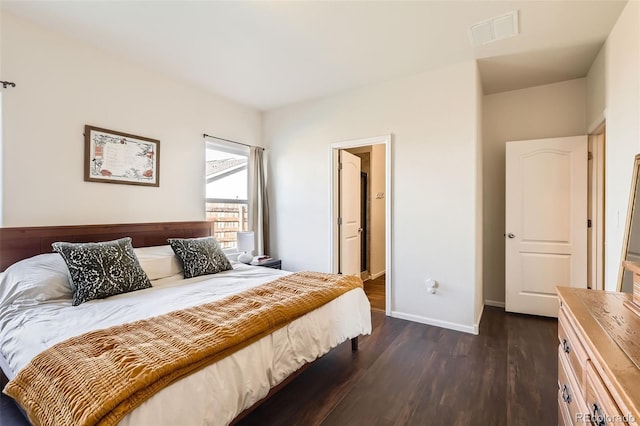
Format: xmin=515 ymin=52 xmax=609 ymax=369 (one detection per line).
xmin=0 ymin=12 xmax=262 ymax=226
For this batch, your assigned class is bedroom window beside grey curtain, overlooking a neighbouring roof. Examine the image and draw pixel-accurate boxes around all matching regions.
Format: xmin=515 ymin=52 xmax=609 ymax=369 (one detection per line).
xmin=205 ymin=138 xmax=249 ymax=249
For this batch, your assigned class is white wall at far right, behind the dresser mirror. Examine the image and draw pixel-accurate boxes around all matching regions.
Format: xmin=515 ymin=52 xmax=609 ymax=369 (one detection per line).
xmin=604 ymin=1 xmax=640 ymax=290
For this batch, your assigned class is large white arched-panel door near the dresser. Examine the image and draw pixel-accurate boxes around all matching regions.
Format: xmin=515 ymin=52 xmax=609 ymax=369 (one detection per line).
xmin=505 ymin=136 xmax=587 ymax=317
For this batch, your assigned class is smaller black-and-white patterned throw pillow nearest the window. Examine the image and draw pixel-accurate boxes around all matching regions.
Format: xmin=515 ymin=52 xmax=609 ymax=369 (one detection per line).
xmin=167 ymin=237 xmax=233 ymax=278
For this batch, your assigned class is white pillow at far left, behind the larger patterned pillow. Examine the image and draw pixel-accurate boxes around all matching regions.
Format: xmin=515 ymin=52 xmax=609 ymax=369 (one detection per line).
xmin=0 ymin=253 xmax=73 ymax=307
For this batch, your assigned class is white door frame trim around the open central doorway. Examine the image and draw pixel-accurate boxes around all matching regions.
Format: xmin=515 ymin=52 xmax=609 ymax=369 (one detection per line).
xmin=329 ymin=134 xmax=393 ymax=316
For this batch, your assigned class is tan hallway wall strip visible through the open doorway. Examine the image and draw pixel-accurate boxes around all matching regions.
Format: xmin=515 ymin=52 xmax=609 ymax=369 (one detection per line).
xmin=370 ymin=144 xmax=386 ymax=278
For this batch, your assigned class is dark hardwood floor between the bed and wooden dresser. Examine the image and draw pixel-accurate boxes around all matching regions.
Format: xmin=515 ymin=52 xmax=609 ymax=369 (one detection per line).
xmin=0 ymin=307 xmax=558 ymax=426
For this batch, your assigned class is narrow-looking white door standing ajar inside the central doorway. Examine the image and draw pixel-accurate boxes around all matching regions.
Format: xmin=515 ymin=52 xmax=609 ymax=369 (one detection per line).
xmin=338 ymin=150 xmax=362 ymax=276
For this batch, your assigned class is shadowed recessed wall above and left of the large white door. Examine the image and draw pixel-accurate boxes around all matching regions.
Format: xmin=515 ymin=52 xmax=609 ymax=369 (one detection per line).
xmin=482 ymin=78 xmax=586 ymax=306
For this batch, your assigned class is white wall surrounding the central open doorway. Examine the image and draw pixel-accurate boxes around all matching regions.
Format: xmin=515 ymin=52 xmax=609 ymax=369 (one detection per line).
xmin=264 ymin=62 xmax=478 ymax=331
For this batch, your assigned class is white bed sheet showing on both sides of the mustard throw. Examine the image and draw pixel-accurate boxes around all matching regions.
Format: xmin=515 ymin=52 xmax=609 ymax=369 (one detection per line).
xmin=0 ymin=264 xmax=371 ymax=426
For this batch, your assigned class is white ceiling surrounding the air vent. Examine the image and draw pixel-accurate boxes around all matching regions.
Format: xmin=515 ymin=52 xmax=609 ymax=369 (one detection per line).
xmin=0 ymin=0 xmax=637 ymax=110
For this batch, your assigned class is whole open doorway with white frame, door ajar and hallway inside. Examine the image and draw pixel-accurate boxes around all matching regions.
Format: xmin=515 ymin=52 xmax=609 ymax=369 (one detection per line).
xmin=330 ymin=135 xmax=392 ymax=315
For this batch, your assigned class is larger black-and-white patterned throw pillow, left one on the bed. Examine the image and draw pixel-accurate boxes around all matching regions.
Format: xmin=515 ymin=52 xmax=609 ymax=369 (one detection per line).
xmin=51 ymin=237 xmax=151 ymax=306
